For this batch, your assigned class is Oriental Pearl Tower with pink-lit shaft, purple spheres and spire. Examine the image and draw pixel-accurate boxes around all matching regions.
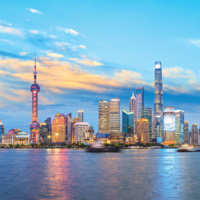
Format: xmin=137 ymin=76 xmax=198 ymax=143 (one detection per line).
xmin=30 ymin=58 xmax=43 ymax=143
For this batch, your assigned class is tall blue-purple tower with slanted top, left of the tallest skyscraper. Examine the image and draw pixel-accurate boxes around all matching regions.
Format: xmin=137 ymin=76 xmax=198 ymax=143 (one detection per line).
xmin=136 ymin=87 xmax=144 ymax=120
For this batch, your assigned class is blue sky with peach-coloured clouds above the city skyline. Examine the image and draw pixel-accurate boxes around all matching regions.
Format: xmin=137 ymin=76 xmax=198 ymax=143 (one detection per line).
xmin=0 ymin=0 xmax=200 ymax=132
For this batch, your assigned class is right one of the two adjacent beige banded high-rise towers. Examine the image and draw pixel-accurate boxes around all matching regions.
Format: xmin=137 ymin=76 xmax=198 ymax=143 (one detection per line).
xmin=109 ymin=98 xmax=120 ymax=133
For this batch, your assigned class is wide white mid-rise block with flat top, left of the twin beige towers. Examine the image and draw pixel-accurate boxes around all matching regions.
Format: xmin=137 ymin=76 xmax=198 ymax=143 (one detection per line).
xmin=74 ymin=122 xmax=89 ymax=143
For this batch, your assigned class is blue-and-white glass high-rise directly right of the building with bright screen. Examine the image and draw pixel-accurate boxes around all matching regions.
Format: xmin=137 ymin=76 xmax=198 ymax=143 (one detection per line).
xmin=175 ymin=110 xmax=184 ymax=144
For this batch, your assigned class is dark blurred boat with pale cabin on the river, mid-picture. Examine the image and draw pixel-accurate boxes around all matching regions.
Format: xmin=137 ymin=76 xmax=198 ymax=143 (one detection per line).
xmin=86 ymin=141 xmax=120 ymax=153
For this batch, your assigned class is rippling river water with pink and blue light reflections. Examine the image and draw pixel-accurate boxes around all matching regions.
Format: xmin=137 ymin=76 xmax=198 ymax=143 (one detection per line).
xmin=0 ymin=149 xmax=200 ymax=200
